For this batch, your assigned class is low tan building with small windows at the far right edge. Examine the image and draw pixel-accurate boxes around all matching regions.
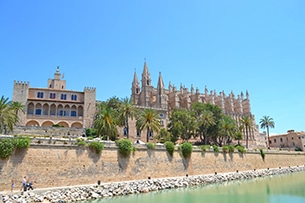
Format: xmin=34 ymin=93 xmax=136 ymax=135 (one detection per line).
xmin=269 ymin=130 xmax=305 ymax=151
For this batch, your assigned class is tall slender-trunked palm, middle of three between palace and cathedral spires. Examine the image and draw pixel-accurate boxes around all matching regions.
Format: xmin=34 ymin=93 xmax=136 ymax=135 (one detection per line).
xmin=119 ymin=97 xmax=137 ymax=138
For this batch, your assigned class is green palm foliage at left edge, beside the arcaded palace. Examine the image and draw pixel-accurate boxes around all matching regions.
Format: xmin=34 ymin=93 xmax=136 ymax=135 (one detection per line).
xmin=0 ymin=96 xmax=19 ymax=133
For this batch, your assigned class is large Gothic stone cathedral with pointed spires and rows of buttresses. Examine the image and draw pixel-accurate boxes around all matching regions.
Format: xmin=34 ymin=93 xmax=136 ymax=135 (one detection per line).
xmin=131 ymin=61 xmax=264 ymax=145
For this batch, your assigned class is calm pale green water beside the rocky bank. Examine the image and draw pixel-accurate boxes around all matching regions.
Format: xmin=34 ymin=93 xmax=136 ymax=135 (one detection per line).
xmin=83 ymin=172 xmax=305 ymax=203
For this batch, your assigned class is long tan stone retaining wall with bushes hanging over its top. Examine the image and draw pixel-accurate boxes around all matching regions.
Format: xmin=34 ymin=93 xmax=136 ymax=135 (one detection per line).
xmin=0 ymin=144 xmax=305 ymax=191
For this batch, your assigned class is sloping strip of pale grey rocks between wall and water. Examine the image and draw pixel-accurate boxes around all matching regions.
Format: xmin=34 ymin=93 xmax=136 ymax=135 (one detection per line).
xmin=0 ymin=166 xmax=305 ymax=203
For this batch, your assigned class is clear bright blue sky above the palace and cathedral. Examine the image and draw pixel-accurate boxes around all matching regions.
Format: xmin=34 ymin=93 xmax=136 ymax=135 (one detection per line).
xmin=0 ymin=0 xmax=305 ymax=134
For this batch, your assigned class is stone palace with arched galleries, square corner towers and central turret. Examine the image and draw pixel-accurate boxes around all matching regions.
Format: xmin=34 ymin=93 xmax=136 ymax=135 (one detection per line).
xmin=12 ymin=67 xmax=96 ymax=128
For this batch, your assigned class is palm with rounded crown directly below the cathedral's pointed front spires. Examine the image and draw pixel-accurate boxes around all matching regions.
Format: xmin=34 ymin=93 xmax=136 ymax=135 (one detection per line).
xmin=138 ymin=109 xmax=160 ymax=142
